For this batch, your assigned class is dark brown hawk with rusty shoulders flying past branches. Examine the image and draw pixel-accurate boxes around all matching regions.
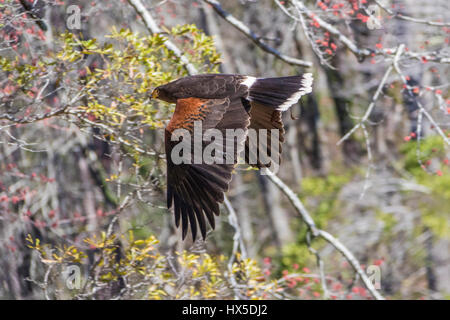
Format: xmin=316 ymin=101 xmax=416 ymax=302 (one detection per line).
xmin=152 ymin=73 xmax=313 ymax=240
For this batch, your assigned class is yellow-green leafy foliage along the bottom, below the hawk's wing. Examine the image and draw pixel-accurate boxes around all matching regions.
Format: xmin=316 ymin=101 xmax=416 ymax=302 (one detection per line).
xmin=27 ymin=232 xmax=279 ymax=299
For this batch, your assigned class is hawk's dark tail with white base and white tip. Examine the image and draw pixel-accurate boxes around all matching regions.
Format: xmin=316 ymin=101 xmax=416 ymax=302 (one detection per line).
xmin=245 ymin=73 xmax=313 ymax=111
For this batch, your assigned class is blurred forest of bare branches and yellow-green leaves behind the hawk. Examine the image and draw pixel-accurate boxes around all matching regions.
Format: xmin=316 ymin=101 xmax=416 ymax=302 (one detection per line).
xmin=0 ymin=0 xmax=450 ymax=299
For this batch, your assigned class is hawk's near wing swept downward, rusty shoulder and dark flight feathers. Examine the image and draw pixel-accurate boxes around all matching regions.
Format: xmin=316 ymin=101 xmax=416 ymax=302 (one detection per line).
xmin=165 ymin=98 xmax=250 ymax=239
